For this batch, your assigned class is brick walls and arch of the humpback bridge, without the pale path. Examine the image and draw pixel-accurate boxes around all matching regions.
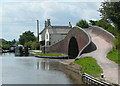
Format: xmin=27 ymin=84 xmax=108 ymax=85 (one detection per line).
xmin=46 ymin=26 xmax=114 ymax=58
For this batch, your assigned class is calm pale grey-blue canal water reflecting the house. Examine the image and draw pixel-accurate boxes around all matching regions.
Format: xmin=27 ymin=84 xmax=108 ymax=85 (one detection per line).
xmin=1 ymin=53 xmax=74 ymax=84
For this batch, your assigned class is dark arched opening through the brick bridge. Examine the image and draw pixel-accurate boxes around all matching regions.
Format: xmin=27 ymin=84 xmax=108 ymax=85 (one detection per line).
xmin=68 ymin=37 xmax=79 ymax=58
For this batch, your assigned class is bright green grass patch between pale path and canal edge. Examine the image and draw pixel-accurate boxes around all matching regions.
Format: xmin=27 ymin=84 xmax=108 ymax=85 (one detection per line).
xmin=74 ymin=57 xmax=103 ymax=77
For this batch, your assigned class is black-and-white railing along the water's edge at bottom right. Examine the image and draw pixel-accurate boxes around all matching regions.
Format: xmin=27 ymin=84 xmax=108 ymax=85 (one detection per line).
xmin=82 ymin=73 xmax=113 ymax=86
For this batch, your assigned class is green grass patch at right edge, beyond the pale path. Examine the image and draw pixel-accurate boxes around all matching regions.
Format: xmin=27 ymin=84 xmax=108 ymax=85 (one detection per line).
xmin=107 ymin=50 xmax=120 ymax=64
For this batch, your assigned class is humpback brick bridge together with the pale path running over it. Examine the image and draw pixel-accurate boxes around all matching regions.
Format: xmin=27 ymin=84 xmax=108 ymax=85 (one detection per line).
xmin=44 ymin=26 xmax=120 ymax=84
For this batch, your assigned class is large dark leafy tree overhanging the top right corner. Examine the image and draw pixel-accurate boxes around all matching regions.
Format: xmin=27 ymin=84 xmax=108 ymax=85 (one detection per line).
xmin=99 ymin=1 xmax=120 ymax=32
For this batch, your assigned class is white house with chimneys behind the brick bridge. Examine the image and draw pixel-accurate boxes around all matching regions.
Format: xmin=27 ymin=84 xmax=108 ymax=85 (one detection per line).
xmin=39 ymin=19 xmax=72 ymax=46
